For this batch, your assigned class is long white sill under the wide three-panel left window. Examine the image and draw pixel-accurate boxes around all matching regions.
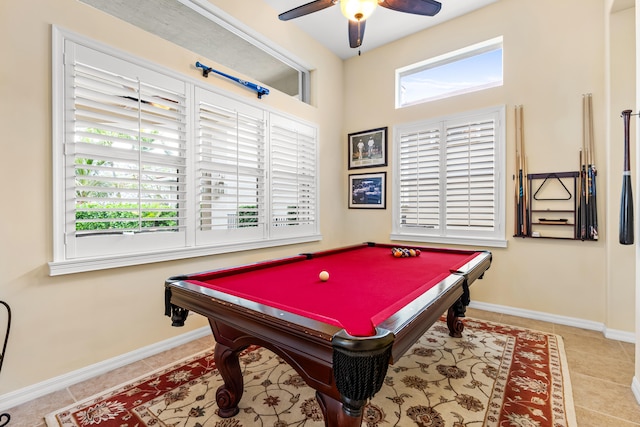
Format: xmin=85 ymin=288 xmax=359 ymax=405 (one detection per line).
xmin=49 ymin=234 xmax=322 ymax=276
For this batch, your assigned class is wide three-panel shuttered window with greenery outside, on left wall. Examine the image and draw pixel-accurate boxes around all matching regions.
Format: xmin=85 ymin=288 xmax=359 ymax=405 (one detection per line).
xmin=50 ymin=29 xmax=319 ymax=275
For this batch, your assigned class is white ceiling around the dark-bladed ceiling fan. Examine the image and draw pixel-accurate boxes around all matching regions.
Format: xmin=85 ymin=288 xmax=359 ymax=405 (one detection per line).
xmin=264 ymin=0 xmax=498 ymax=59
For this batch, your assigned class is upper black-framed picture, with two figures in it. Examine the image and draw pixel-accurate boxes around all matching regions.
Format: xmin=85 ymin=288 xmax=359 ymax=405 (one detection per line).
xmin=348 ymin=127 xmax=387 ymax=169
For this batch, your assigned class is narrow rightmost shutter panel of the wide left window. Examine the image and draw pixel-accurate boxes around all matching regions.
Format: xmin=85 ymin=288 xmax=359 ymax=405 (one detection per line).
xmin=270 ymin=114 xmax=317 ymax=235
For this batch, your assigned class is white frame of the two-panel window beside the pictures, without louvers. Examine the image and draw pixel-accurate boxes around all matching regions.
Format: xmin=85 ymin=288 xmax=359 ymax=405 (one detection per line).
xmin=390 ymin=105 xmax=507 ymax=247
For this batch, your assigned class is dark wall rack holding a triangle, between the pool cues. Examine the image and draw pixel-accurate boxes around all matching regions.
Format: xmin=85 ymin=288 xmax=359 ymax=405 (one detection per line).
xmin=524 ymin=171 xmax=580 ymax=240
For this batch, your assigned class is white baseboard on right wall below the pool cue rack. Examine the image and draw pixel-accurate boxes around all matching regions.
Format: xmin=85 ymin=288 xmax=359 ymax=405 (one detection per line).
xmin=469 ymin=301 xmax=636 ymax=344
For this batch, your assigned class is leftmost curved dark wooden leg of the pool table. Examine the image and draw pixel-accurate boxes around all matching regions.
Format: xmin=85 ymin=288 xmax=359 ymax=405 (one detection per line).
xmin=214 ymin=343 xmax=244 ymax=418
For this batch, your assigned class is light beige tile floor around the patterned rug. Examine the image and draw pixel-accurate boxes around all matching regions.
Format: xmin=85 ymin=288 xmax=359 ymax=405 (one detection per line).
xmin=7 ymin=309 xmax=640 ymax=427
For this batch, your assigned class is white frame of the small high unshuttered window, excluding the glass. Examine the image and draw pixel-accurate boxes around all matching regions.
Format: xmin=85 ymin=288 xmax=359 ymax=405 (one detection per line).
xmin=395 ymin=36 xmax=504 ymax=109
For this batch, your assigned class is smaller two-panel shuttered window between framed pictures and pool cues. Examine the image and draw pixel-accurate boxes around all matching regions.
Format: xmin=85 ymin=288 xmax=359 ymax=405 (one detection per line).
xmin=392 ymin=107 xmax=506 ymax=246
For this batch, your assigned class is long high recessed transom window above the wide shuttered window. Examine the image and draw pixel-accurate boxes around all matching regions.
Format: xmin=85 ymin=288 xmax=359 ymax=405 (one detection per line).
xmin=80 ymin=0 xmax=310 ymax=103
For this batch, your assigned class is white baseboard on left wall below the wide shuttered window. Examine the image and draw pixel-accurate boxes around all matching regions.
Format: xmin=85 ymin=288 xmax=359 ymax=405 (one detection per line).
xmin=0 ymin=326 xmax=211 ymax=412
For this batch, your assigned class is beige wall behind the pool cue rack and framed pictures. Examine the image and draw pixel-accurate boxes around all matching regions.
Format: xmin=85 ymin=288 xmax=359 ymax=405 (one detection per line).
xmin=345 ymin=0 xmax=634 ymax=332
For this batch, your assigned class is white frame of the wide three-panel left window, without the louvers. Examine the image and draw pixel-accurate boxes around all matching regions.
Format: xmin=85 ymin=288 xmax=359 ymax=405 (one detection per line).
xmin=49 ymin=26 xmax=321 ymax=276
